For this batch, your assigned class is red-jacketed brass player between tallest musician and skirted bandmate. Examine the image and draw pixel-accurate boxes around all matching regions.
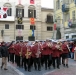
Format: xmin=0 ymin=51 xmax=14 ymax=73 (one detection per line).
xmin=52 ymin=42 xmax=62 ymax=69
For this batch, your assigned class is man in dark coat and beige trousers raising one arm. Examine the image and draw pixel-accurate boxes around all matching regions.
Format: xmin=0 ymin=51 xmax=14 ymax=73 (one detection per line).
xmin=0 ymin=41 xmax=13 ymax=70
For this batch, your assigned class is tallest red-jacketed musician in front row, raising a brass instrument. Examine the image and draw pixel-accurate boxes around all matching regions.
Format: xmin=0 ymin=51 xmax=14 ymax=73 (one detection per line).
xmin=41 ymin=39 xmax=53 ymax=70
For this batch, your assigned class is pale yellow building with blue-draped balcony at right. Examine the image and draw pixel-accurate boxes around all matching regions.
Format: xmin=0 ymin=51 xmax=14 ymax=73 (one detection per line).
xmin=54 ymin=0 xmax=76 ymax=39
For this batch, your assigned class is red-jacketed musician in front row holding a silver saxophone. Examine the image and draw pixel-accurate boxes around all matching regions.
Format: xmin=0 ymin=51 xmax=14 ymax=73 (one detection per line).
xmin=32 ymin=41 xmax=41 ymax=71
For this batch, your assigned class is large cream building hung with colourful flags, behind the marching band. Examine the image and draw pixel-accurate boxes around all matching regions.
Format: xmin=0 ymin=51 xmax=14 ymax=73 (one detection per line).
xmin=0 ymin=0 xmax=53 ymax=42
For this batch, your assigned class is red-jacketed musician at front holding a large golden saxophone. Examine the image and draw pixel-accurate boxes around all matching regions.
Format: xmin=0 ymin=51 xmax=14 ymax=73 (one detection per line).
xmin=23 ymin=42 xmax=32 ymax=72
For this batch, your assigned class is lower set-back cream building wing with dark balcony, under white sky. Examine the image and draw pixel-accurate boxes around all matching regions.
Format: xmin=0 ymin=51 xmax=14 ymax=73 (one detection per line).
xmin=41 ymin=8 xmax=53 ymax=40
